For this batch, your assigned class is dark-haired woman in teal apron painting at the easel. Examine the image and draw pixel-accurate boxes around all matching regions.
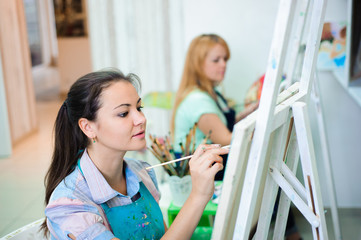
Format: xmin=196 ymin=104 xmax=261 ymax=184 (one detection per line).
xmin=43 ymin=70 xmax=228 ymax=239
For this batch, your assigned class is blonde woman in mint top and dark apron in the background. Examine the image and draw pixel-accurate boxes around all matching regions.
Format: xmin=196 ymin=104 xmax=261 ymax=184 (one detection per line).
xmin=171 ymin=34 xmax=258 ymax=180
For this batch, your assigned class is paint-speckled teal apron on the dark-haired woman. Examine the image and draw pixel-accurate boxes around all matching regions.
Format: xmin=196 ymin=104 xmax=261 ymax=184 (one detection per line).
xmin=78 ymin=161 xmax=165 ymax=240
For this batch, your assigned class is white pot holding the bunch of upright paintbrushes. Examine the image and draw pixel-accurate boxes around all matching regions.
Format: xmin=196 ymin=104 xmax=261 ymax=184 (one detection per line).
xmin=168 ymin=175 xmax=192 ymax=207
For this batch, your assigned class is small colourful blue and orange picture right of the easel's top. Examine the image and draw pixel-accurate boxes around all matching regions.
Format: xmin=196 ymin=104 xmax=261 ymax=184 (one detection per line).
xmin=317 ymin=22 xmax=346 ymax=70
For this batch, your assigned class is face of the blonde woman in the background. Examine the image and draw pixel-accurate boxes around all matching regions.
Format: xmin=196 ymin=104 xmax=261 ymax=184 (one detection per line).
xmin=203 ymin=44 xmax=227 ymax=86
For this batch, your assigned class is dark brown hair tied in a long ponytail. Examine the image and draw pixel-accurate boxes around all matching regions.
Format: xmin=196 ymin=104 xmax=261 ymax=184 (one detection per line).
xmin=41 ymin=68 xmax=141 ymax=236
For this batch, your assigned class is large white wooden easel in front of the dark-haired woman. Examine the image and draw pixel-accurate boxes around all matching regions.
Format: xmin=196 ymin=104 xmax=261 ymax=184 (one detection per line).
xmin=212 ymin=0 xmax=328 ymax=239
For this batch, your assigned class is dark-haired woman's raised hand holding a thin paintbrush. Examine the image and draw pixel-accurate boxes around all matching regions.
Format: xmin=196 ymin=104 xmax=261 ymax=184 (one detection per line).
xmin=189 ymin=144 xmax=229 ymax=202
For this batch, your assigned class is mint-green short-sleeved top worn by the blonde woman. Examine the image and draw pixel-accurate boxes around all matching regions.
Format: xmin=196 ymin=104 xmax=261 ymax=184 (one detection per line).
xmin=173 ymin=89 xmax=227 ymax=152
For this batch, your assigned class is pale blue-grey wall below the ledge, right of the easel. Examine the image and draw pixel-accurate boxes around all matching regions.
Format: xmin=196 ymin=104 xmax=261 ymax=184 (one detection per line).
xmin=310 ymin=72 xmax=361 ymax=207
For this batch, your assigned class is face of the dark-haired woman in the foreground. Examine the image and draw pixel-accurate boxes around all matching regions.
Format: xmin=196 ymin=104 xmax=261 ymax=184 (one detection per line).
xmin=94 ymin=81 xmax=146 ymax=151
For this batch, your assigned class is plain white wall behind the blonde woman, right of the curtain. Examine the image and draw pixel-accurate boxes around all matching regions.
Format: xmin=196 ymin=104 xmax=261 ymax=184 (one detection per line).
xmin=184 ymin=0 xmax=279 ymax=103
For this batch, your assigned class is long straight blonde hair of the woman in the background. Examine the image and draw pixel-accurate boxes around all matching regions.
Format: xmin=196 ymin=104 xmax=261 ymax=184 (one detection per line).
xmin=170 ymin=34 xmax=230 ymax=136
